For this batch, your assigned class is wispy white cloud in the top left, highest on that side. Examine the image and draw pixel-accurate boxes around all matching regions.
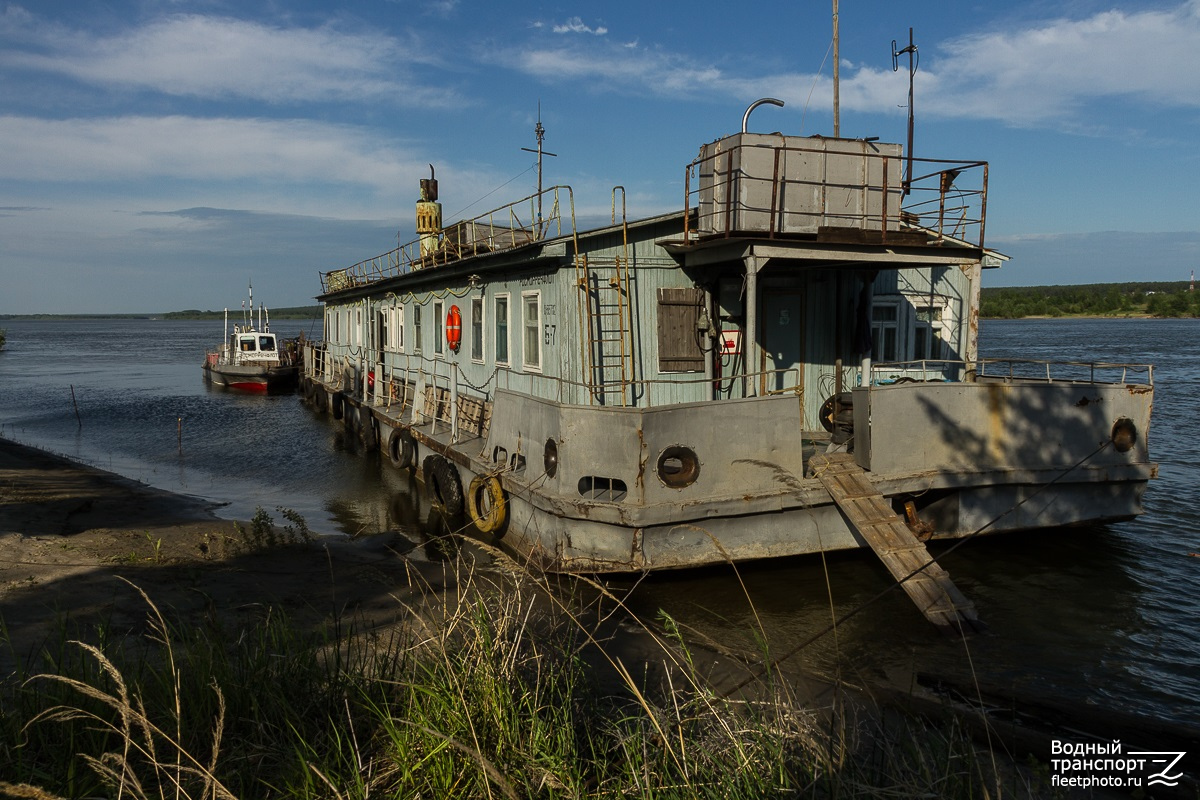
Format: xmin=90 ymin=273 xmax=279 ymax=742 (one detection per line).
xmin=0 ymin=8 xmax=455 ymax=106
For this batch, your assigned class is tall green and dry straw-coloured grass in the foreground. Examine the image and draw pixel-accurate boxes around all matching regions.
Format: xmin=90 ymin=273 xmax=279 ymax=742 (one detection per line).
xmin=0 ymin=563 xmax=1025 ymax=800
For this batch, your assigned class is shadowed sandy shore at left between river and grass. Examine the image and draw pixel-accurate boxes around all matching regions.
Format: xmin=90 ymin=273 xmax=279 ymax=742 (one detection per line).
xmin=0 ymin=439 xmax=454 ymax=672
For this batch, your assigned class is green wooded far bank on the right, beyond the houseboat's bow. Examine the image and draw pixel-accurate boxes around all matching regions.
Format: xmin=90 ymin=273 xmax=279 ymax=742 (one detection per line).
xmin=979 ymin=281 xmax=1200 ymax=319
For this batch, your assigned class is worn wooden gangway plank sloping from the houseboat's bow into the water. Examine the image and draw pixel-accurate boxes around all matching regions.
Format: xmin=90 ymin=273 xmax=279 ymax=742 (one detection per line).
xmin=809 ymin=453 xmax=983 ymax=633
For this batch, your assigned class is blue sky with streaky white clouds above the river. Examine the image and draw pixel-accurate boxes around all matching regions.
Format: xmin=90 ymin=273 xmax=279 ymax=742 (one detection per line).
xmin=0 ymin=0 xmax=1200 ymax=313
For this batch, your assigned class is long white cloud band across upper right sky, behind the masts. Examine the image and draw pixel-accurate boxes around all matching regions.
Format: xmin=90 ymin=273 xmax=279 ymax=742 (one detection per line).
xmin=500 ymin=0 xmax=1200 ymax=130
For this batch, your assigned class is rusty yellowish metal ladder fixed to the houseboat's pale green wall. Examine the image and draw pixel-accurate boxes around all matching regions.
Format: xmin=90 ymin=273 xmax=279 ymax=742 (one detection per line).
xmin=575 ymin=186 xmax=634 ymax=407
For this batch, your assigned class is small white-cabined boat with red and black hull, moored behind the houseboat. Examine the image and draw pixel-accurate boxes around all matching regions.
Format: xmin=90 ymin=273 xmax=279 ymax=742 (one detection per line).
xmin=204 ymin=290 xmax=300 ymax=393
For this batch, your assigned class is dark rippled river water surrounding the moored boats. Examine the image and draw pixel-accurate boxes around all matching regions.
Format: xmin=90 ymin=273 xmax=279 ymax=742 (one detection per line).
xmin=0 ymin=320 xmax=1200 ymax=738
